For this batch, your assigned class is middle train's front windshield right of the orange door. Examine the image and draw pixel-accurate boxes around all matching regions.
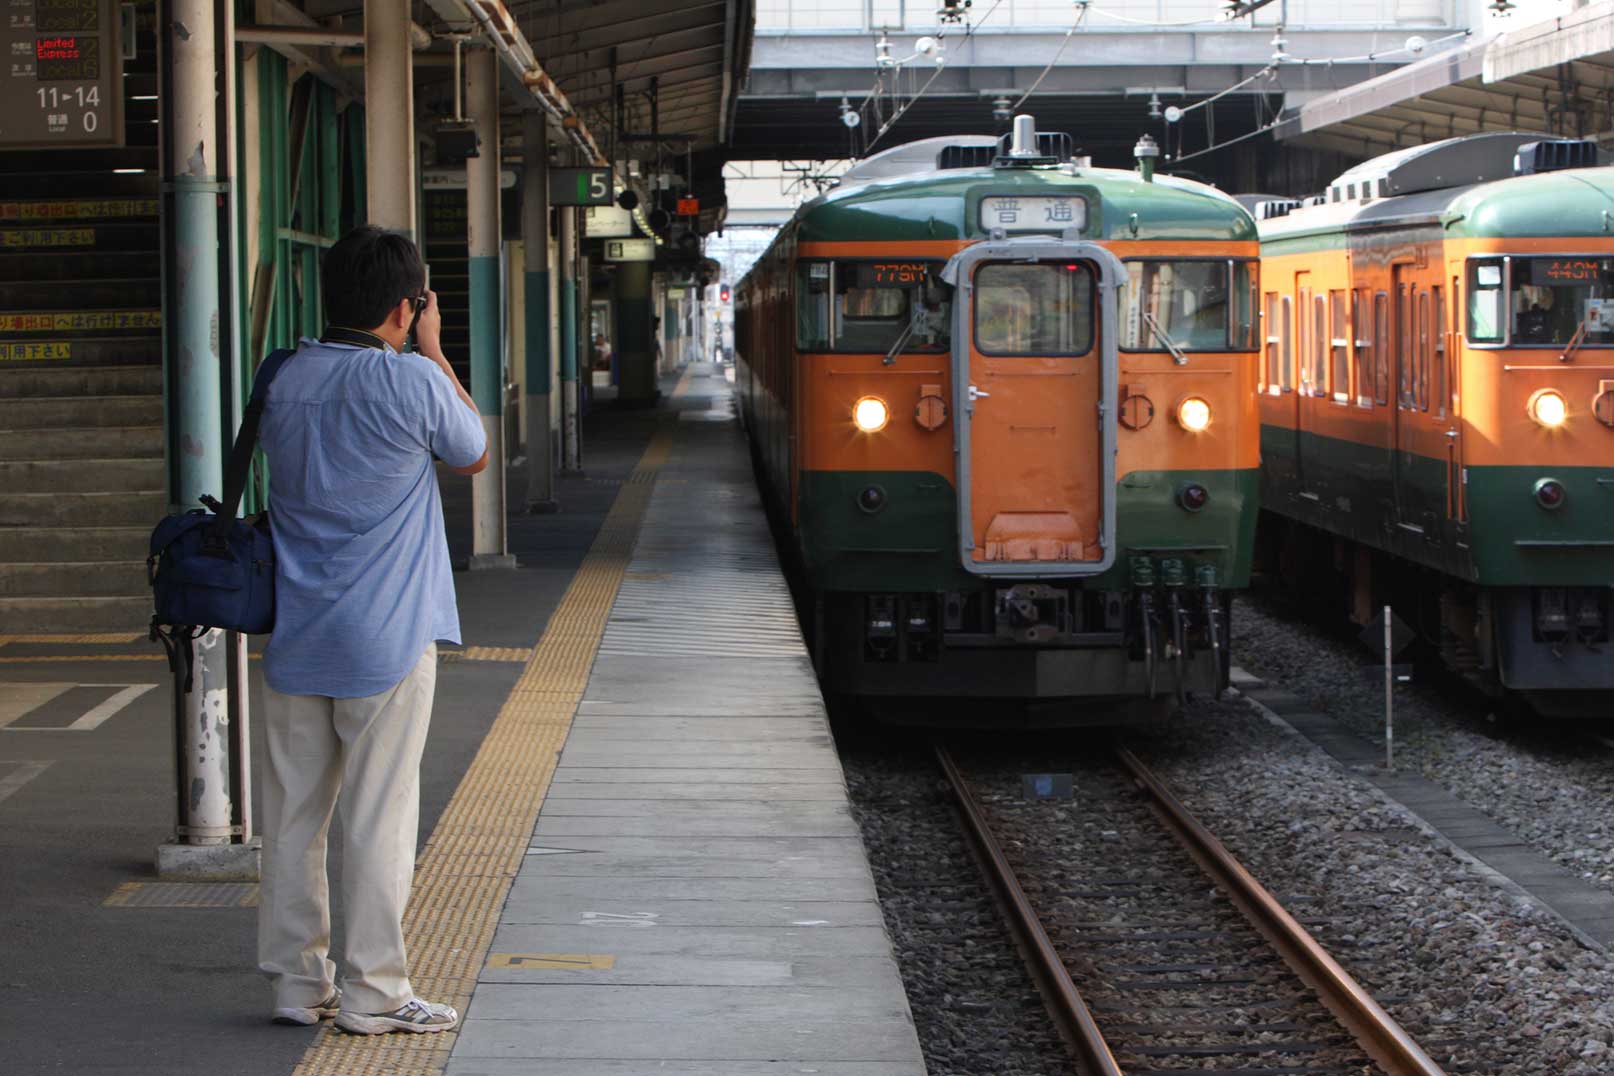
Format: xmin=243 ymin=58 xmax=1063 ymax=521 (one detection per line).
xmin=1119 ymin=258 xmax=1257 ymax=352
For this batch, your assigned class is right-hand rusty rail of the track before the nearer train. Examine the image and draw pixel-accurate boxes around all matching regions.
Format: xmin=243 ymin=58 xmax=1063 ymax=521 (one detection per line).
xmin=1115 ymin=747 xmax=1445 ymax=1076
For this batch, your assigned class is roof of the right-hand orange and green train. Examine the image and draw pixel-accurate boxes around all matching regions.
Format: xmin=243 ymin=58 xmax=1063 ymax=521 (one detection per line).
xmin=1254 ymin=132 xmax=1614 ymax=250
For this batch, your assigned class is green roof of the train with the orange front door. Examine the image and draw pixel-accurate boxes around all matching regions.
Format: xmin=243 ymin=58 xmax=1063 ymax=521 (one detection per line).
xmin=794 ymin=158 xmax=1256 ymax=242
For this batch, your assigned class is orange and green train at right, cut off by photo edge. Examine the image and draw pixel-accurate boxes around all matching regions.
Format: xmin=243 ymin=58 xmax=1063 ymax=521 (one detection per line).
xmin=1256 ymin=134 xmax=1614 ymax=713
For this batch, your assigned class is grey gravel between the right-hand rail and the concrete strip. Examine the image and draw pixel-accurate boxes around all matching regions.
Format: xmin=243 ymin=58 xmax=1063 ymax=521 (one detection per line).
xmin=1133 ymin=702 xmax=1614 ymax=1076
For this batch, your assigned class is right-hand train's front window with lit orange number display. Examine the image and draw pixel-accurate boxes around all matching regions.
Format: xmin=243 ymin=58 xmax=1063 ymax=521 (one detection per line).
xmin=1507 ymin=255 xmax=1614 ymax=347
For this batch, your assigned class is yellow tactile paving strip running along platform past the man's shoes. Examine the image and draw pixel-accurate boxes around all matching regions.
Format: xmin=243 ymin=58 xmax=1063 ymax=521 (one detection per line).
xmin=294 ymin=427 xmax=671 ymax=1076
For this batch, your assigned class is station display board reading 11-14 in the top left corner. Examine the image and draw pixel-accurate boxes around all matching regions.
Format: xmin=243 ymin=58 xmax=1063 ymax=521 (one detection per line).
xmin=0 ymin=0 xmax=123 ymax=148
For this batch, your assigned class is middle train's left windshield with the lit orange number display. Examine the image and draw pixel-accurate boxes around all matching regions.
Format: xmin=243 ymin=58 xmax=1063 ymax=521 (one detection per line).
xmin=796 ymin=258 xmax=952 ymax=355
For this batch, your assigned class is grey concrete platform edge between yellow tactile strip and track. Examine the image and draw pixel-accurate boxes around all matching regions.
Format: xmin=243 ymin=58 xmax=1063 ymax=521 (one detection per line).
xmin=447 ymin=367 xmax=925 ymax=1076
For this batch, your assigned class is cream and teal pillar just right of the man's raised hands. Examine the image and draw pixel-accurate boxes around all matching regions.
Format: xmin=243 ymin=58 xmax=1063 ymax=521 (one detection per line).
xmin=465 ymin=48 xmax=515 ymax=568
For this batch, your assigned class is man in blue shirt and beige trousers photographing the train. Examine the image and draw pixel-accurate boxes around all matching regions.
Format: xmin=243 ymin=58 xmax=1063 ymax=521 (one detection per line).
xmin=258 ymin=227 xmax=487 ymax=1034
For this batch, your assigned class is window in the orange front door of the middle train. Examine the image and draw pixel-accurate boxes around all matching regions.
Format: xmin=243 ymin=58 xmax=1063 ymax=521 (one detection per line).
xmin=975 ymin=261 xmax=1093 ymax=355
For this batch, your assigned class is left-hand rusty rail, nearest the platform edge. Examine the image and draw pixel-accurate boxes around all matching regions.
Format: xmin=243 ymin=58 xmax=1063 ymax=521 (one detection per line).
xmin=935 ymin=744 xmax=1123 ymax=1076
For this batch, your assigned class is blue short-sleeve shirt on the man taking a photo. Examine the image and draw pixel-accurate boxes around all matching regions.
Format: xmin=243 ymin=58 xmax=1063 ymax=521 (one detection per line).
xmin=258 ymin=339 xmax=487 ymax=699
